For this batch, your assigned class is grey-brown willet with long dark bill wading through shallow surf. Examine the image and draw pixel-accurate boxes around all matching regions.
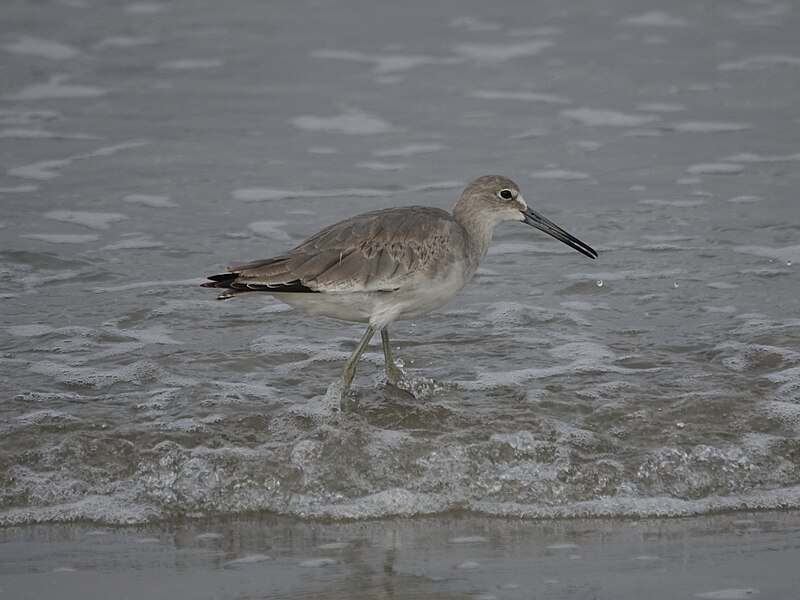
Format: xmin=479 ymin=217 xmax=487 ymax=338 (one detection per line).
xmin=203 ymin=175 xmax=597 ymax=400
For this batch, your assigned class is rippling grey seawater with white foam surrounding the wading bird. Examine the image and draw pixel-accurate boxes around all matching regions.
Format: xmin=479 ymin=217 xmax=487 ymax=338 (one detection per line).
xmin=0 ymin=0 xmax=800 ymax=525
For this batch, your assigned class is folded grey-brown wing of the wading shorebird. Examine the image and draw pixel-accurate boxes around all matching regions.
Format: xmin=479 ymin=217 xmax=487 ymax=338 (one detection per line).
xmin=222 ymin=206 xmax=465 ymax=292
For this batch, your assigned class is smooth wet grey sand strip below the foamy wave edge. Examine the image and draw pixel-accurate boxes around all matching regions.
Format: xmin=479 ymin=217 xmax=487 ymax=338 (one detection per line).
xmin=0 ymin=512 xmax=800 ymax=600
